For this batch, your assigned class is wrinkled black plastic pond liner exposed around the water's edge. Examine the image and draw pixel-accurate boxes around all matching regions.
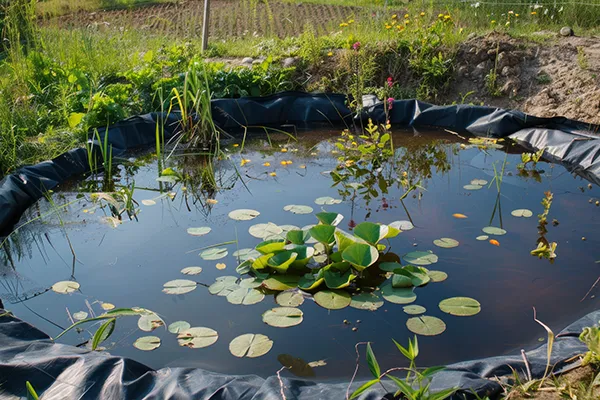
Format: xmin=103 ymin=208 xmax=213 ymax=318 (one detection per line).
xmin=0 ymin=92 xmax=600 ymax=400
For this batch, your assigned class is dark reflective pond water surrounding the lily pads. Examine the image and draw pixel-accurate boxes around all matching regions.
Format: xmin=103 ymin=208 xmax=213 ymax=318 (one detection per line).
xmin=0 ymin=131 xmax=600 ymax=380
